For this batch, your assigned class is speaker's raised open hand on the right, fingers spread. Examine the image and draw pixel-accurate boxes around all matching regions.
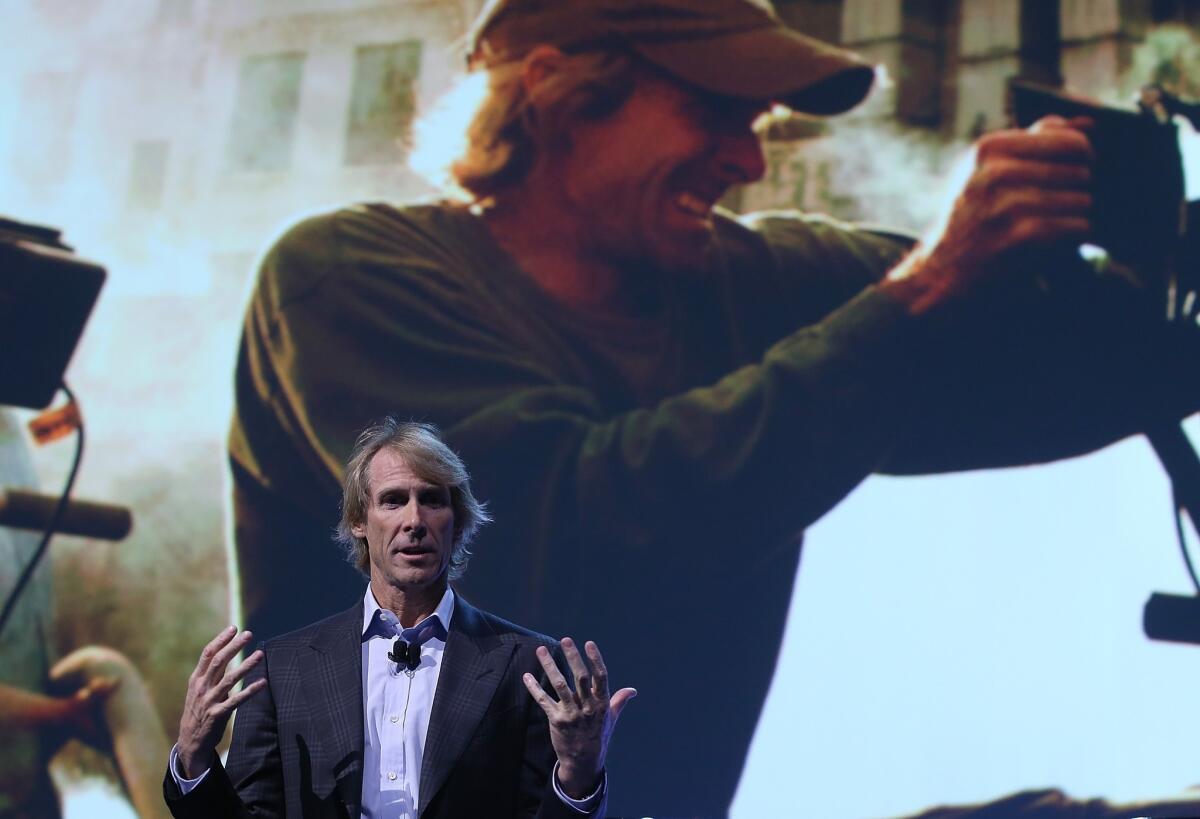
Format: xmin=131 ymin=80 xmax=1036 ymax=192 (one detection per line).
xmin=523 ymin=638 xmax=637 ymax=799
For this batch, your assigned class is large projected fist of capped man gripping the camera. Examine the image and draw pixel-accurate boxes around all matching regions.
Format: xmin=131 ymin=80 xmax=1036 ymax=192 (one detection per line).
xmin=884 ymin=116 xmax=1094 ymax=313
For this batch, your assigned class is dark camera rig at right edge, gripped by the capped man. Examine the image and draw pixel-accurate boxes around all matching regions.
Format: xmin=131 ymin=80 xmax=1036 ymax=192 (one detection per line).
xmin=1009 ymin=80 xmax=1200 ymax=644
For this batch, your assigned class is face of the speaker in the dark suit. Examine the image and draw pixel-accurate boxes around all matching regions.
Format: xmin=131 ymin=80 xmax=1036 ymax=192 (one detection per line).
xmin=350 ymin=448 xmax=455 ymax=592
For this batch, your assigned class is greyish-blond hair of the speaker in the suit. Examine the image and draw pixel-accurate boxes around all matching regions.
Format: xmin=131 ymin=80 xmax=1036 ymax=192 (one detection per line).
xmin=335 ymin=416 xmax=492 ymax=580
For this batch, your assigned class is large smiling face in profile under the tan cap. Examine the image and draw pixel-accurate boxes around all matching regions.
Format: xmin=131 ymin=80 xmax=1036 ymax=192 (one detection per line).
xmin=551 ymin=66 xmax=768 ymax=270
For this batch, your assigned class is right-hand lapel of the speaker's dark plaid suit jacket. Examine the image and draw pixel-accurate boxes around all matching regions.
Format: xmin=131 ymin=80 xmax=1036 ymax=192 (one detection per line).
xmin=418 ymin=596 xmax=515 ymax=815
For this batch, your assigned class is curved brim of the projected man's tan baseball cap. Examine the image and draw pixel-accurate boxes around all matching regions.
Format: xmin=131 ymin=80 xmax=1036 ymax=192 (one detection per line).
xmin=631 ymin=25 xmax=875 ymax=115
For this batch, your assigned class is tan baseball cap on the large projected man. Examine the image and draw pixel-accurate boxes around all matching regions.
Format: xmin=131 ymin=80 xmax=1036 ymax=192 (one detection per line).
xmin=468 ymin=0 xmax=875 ymax=114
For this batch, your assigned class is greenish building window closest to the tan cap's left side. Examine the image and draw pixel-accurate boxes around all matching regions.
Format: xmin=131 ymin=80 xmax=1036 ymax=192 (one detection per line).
xmin=344 ymin=40 xmax=421 ymax=165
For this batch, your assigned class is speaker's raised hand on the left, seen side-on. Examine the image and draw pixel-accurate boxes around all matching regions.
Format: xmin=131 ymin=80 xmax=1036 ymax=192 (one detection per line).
xmin=175 ymin=626 xmax=266 ymax=779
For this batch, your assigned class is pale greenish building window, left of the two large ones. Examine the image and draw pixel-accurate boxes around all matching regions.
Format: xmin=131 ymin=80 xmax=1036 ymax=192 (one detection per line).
xmin=226 ymin=52 xmax=304 ymax=171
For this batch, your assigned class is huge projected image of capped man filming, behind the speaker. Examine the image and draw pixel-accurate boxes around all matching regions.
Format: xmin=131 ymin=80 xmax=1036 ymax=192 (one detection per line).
xmin=7 ymin=0 xmax=1200 ymax=818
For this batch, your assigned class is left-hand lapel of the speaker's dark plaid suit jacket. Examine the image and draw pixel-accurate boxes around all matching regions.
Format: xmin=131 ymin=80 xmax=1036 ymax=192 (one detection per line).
xmin=300 ymin=602 xmax=362 ymax=817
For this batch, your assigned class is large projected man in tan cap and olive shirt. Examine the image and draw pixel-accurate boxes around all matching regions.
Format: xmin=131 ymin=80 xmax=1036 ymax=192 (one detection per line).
xmin=230 ymin=0 xmax=1200 ymax=817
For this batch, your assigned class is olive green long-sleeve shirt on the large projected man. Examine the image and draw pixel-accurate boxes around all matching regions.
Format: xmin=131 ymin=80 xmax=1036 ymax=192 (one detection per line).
xmin=230 ymin=204 xmax=1194 ymax=815
